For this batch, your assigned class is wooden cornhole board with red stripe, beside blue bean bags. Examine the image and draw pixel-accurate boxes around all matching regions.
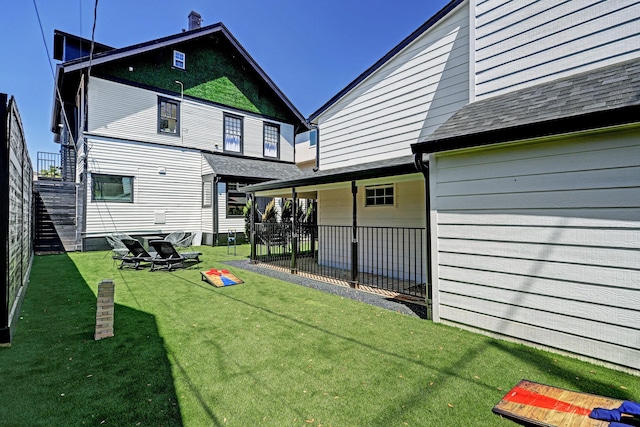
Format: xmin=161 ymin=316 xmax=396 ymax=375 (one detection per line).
xmin=493 ymin=380 xmax=623 ymax=427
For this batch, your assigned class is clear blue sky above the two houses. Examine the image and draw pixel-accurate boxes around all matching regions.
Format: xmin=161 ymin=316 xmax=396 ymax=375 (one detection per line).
xmin=0 ymin=0 xmax=448 ymax=168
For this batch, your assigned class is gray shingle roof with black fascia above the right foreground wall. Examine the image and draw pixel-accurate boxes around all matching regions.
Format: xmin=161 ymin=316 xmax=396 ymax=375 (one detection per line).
xmin=411 ymin=59 xmax=640 ymax=153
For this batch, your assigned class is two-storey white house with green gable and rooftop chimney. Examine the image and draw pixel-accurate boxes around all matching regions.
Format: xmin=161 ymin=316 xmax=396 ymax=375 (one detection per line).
xmin=51 ymin=12 xmax=307 ymax=250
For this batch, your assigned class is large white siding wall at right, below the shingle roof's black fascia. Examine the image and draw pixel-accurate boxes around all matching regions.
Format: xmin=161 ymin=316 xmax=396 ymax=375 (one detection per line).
xmin=430 ymin=131 xmax=640 ymax=368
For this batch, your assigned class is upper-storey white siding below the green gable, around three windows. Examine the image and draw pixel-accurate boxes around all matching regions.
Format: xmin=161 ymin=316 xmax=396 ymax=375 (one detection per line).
xmin=88 ymin=77 xmax=294 ymax=162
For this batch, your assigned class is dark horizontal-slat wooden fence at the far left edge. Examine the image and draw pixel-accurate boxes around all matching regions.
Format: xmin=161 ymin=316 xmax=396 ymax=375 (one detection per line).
xmin=0 ymin=93 xmax=33 ymax=344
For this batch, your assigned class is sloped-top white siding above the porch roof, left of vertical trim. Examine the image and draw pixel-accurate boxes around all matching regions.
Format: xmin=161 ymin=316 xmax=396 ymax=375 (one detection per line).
xmin=318 ymin=2 xmax=469 ymax=169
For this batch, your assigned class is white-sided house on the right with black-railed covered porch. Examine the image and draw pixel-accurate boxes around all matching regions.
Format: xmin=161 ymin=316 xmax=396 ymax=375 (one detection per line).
xmin=242 ymin=0 xmax=640 ymax=372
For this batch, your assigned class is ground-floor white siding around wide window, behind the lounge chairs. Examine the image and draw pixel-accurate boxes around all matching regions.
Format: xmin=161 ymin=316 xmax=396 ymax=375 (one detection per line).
xmin=86 ymin=139 xmax=202 ymax=234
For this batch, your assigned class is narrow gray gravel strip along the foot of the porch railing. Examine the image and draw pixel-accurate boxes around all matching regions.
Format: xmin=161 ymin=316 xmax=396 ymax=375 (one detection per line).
xmin=225 ymin=260 xmax=427 ymax=319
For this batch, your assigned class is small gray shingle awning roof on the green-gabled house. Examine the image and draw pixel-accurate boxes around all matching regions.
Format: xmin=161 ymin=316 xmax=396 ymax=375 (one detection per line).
xmin=203 ymin=153 xmax=302 ymax=181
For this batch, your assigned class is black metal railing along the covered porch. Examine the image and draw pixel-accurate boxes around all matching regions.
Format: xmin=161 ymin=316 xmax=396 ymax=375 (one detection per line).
xmin=254 ymin=223 xmax=426 ymax=298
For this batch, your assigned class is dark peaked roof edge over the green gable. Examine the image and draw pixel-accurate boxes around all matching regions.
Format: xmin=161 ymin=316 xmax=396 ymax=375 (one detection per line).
xmin=54 ymin=22 xmax=306 ymax=128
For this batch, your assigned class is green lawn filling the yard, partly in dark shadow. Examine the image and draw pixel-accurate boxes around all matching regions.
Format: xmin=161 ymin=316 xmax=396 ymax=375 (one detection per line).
xmin=0 ymin=245 xmax=640 ymax=427
